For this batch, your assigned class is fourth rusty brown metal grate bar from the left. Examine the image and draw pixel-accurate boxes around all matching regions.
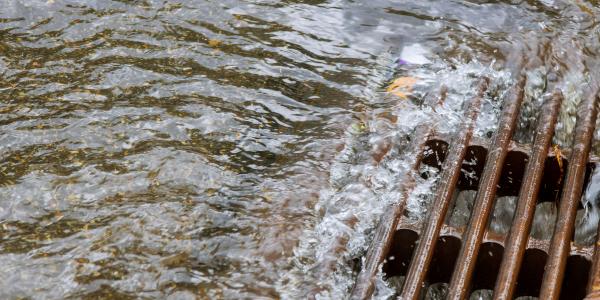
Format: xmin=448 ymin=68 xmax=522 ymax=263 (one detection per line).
xmin=494 ymin=90 xmax=563 ymax=300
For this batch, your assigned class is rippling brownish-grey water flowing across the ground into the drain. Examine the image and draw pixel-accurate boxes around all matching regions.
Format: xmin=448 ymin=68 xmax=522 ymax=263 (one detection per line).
xmin=0 ymin=0 xmax=600 ymax=299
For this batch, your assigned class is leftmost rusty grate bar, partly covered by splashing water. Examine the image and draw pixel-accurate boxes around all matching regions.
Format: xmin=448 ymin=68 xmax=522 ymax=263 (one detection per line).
xmin=351 ymin=86 xmax=448 ymax=299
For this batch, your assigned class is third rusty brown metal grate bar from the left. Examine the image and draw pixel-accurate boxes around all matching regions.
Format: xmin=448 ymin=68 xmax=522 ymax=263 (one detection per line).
xmin=448 ymin=75 xmax=525 ymax=299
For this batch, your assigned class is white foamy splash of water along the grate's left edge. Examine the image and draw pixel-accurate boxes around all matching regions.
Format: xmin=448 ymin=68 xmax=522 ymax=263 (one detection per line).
xmin=279 ymin=46 xmax=511 ymax=299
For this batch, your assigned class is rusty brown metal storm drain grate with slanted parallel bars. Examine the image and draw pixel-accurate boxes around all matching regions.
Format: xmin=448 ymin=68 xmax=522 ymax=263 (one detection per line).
xmin=352 ymin=76 xmax=600 ymax=299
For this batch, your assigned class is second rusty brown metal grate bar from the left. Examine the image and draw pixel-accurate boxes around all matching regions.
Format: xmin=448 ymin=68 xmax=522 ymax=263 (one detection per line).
xmin=400 ymin=78 xmax=489 ymax=299
